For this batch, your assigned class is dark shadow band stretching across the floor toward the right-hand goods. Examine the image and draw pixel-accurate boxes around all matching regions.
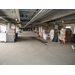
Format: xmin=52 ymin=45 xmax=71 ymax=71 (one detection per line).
xmin=16 ymin=37 xmax=47 ymax=45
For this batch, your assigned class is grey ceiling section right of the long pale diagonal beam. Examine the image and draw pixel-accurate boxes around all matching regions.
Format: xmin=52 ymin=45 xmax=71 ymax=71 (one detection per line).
xmin=25 ymin=9 xmax=75 ymax=27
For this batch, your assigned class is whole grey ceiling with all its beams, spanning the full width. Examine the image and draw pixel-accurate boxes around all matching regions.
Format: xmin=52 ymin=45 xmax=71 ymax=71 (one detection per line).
xmin=0 ymin=9 xmax=75 ymax=27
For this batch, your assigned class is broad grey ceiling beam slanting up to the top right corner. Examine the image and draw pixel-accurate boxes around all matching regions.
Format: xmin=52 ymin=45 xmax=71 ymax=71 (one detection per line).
xmin=39 ymin=9 xmax=75 ymax=23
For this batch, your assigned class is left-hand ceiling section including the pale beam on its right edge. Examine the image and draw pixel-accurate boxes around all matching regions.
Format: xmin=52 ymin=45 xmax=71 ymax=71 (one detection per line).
xmin=0 ymin=9 xmax=20 ymax=22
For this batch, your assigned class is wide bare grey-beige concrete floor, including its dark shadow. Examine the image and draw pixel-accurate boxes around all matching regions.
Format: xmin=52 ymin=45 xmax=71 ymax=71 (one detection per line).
xmin=0 ymin=31 xmax=75 ymax=65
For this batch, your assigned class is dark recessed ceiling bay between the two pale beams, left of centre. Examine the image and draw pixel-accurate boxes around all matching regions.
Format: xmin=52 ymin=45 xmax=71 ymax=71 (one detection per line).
xmin=19 ymin=9 xmax=39 ymax=25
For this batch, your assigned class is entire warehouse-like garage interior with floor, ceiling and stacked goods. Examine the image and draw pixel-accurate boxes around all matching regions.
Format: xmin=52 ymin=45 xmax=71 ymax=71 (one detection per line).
xmin=0 ymin=9 xmax=75 ymax=65
